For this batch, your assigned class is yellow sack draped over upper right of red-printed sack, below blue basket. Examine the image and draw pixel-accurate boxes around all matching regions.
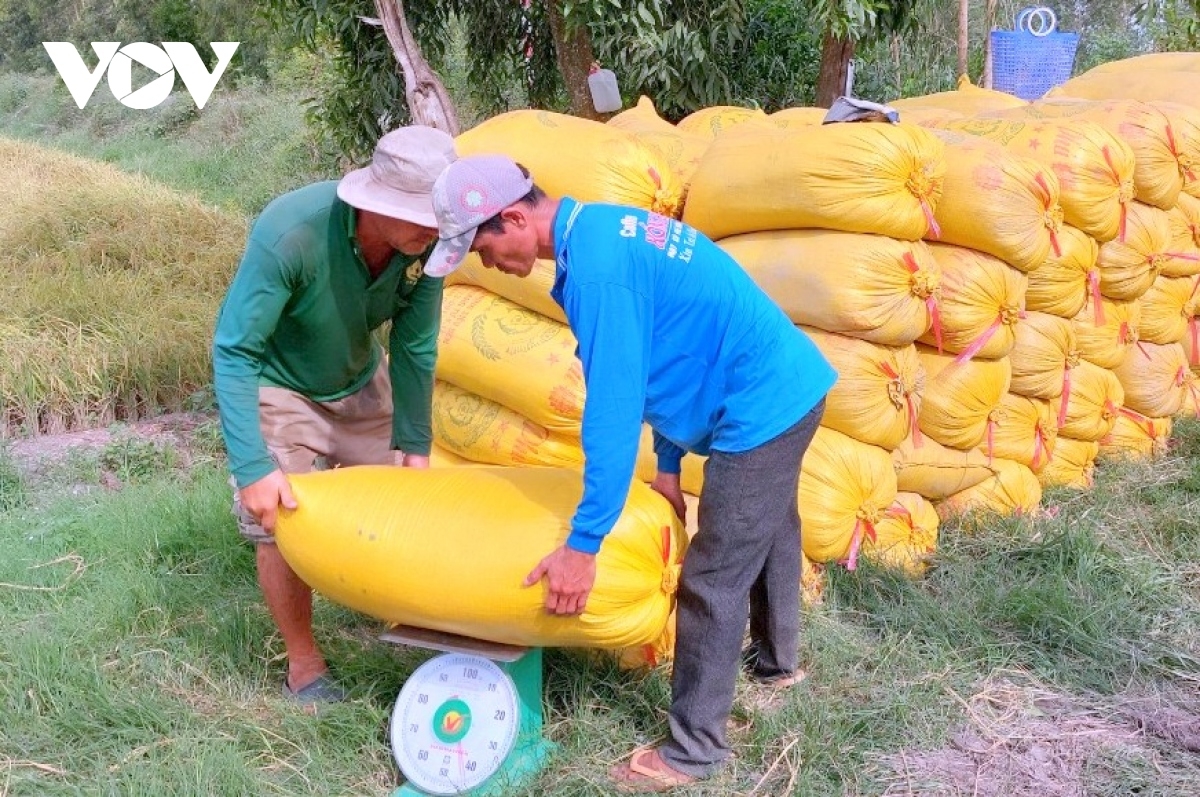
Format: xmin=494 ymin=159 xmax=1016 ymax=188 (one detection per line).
xmin=946 ymin=119 xmax=1134 ymax=241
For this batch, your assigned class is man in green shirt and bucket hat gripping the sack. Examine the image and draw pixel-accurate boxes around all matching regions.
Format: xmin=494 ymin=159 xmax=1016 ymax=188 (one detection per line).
xmin=212 ymin=126 xmax=455 ymax=703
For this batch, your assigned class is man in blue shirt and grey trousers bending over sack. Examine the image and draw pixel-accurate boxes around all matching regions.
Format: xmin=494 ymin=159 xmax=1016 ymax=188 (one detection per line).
xmin=425 ymin=155 xmax=836 ymax=791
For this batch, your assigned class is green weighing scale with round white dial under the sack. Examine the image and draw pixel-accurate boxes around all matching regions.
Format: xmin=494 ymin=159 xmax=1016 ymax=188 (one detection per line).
xmin=379 ymin=625 xmax=556 ymax=797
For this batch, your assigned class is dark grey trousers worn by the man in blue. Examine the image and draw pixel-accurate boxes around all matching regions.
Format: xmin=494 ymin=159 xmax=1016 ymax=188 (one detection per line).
xmin=661 ymin=401 xmax=824 ymax=778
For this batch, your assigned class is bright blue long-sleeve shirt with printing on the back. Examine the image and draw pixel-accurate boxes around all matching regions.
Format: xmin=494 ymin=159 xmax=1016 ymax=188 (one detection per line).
xmin=551 ymin=198 xmax=836 ymax=553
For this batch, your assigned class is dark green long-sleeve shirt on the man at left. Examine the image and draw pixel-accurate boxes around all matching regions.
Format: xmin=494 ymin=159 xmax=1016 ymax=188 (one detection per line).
xmin=212 ymin=181 xmax=443 ymax=487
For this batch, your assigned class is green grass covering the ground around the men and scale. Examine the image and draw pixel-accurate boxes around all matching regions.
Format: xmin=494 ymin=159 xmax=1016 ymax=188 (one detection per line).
xmin=0 ymin=421 xmax=1200 ymax=796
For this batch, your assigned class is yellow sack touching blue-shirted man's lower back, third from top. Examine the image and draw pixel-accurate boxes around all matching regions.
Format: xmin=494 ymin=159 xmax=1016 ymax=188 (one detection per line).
xmin=803 ymin=326 xmax=925 ymax=449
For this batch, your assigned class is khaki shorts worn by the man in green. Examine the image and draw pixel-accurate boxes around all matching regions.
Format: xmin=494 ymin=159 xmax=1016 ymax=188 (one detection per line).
xmin=229 ymin=362 xmax=400 ymax=545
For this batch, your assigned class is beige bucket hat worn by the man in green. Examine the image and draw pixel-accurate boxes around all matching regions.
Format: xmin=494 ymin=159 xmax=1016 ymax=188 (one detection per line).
xmin=337 ymin=125 xmax=457 ymax=228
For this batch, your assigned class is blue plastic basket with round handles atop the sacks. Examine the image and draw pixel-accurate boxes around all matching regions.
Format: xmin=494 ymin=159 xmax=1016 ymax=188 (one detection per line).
xmin=991 ymin=30 xmax=1079 ymax=100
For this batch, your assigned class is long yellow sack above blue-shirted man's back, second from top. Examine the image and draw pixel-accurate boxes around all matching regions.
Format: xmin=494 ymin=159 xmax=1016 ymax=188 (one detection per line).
xmin=720 ymin=229 xmax=941 ymax=346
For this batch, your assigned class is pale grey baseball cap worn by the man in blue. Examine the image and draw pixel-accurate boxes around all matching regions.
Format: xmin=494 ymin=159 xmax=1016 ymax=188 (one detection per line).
xmin=425 ymin=155 xmax=533 ymax=277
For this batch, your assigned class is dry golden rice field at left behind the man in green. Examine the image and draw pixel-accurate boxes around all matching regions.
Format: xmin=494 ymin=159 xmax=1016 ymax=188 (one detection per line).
xmin=0 ymin=138 xmax=247 ymax=437
